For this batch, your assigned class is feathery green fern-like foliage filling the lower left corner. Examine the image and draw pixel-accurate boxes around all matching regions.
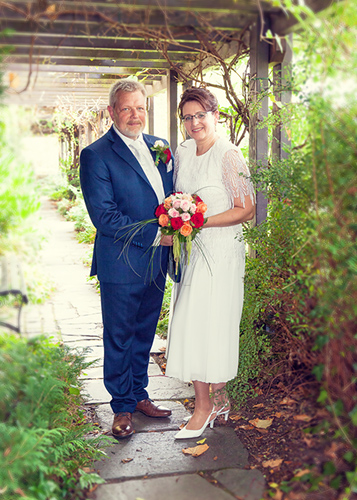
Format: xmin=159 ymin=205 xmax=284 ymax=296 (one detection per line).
xmin=0 ymin=336 xmax=111 ymax=500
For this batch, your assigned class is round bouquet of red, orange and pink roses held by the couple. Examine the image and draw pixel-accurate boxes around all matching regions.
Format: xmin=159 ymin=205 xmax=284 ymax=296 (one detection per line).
xmin=155 ymin=192 xmax=207 ymax=272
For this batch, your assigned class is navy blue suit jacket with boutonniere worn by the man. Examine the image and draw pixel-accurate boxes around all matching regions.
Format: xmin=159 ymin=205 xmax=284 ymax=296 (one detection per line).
xmin=80 ymin=127 xmax=173 ymax=283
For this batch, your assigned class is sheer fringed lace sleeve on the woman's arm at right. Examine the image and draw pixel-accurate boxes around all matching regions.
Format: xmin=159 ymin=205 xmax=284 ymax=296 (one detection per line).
xmin=222 ymin=149 xmax=255 ymax=207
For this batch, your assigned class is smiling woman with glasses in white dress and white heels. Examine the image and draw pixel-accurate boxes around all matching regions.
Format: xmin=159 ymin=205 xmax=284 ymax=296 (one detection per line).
xmin=166 ymin=88 xmax=255 ymax=439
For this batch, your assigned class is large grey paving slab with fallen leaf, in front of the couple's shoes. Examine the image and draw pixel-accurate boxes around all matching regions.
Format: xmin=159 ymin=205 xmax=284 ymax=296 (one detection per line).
xmin=94 ymin=427 xmax=248 ymax=480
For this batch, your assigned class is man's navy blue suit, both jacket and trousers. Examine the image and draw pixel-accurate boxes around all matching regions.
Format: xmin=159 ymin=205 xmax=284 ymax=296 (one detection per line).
xmin=80 ymin=127 xmax=173 ymax=413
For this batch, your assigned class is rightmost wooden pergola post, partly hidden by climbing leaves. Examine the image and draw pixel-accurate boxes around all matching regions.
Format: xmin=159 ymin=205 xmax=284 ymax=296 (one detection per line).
xmin=270 ymin=34 xmax=293 ymax=160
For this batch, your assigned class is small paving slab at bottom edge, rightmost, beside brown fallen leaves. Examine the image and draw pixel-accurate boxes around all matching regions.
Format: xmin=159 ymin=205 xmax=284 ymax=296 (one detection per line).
xmin=212 ymin=469 xmax=265 ymax=500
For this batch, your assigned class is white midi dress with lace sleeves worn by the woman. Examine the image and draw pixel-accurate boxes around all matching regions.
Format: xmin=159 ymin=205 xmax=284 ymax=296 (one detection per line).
xmin=166 ymin=138 xmax=254 ymax=383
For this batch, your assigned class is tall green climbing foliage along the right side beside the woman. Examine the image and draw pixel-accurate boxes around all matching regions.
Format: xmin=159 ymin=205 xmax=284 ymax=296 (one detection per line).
xmin=230 ymin=2 xmax=357 ymax=500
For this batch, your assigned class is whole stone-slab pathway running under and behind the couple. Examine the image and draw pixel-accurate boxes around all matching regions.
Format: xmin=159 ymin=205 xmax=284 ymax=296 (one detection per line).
xmin=23 ymin=199 xmax=264 ymax=500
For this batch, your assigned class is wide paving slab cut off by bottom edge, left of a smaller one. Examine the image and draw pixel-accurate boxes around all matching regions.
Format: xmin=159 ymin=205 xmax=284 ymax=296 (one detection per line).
xmin=89 ymin=474 xmax=234 ymax=500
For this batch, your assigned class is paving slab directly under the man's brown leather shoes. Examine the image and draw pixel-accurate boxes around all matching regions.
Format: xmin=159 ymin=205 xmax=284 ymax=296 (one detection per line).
xmin=95 ymin=401 xmax=190 ymax=433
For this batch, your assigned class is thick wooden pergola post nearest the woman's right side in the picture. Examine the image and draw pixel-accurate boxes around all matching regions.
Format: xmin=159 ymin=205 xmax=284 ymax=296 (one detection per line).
xmin=249 ymin=18 xmax=269 ymax=225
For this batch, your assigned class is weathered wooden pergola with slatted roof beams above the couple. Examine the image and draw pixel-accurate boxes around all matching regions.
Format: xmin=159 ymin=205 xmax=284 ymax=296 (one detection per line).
xmin=0 ymin=0 xmax=334 ymax=223
